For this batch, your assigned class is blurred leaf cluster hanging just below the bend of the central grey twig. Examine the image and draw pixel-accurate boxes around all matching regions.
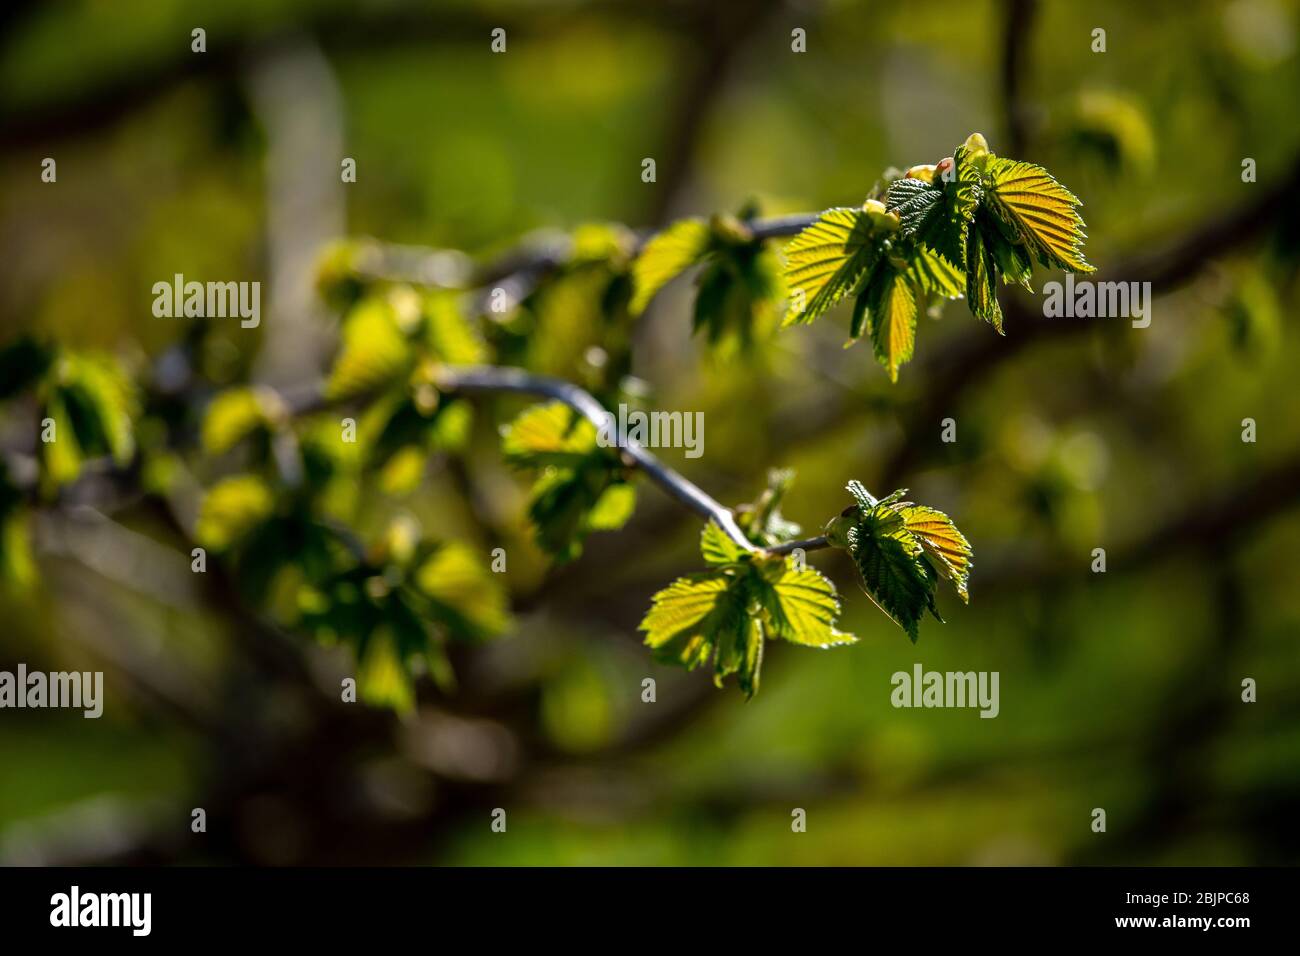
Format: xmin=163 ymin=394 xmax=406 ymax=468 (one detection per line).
xmin=502 ymin=402 xmax=637 ymax=561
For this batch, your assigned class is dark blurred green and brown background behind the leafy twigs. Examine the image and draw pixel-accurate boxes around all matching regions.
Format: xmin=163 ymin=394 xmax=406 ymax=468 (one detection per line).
xmin=0 ymin=0 xmax=1300 ymax=865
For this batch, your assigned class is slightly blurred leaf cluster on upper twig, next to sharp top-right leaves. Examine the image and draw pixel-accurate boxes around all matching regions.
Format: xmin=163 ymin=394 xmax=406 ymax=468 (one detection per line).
xmin=631 ymin=207 xmax=784 ymax=351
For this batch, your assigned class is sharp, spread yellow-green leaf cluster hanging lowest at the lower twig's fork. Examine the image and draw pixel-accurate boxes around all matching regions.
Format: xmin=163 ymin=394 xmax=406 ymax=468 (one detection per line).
xmin=641 ymin=522 xmax=857 ymax=697
